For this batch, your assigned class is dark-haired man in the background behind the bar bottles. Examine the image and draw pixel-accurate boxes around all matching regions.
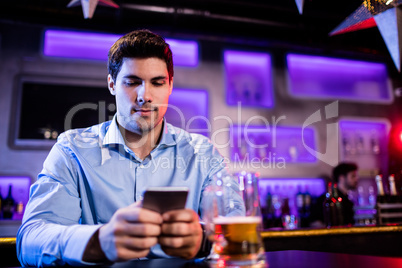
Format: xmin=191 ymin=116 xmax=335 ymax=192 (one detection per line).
xmin=310 ymin=162 xmax=358 ymax=227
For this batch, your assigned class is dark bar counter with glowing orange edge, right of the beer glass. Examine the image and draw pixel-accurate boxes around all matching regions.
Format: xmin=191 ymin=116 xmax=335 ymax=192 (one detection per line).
xmin=261 ymin=225 xmax=402 ymax=257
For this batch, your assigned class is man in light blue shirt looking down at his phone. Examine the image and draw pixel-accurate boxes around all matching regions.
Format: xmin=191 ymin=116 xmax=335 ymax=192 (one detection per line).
xmin=17 ymin=30 xmax=232 ymax=266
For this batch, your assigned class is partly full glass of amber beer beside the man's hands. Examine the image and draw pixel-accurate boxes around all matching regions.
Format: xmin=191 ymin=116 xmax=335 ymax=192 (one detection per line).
xmin=202 ymin=172 xmax=266 ymax=267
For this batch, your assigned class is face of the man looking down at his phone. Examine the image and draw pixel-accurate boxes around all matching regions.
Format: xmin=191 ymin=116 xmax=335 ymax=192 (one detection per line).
xmin=108 ymin=58 xmax=173 ymax=135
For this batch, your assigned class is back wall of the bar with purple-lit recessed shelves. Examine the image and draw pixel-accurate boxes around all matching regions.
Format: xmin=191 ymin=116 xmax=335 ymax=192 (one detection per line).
xmin=0 ymin=22 xmax=401 ymax=218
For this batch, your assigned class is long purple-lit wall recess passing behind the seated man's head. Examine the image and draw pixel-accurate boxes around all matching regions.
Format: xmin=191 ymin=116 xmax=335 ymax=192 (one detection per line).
xmin=43 ymin=30 xmax=198 ymax=67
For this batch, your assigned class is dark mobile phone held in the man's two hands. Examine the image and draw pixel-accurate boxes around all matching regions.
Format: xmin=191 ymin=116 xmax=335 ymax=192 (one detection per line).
xmin=142 ymin=186 xmax=188 ymax=214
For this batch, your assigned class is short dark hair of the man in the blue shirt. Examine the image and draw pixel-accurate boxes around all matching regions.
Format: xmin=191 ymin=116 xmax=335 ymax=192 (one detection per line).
xmin=107 ymin=30 xmax=173 ymax=82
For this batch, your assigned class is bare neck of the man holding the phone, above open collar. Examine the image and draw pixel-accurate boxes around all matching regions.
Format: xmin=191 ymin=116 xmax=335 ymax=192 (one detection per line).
xmin=120 ymin=121 xmax=163 ymax=160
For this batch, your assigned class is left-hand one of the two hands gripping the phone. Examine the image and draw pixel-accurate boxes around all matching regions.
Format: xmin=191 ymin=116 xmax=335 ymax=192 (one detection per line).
xmin=84 ymin=203 xmax=162 ymax=262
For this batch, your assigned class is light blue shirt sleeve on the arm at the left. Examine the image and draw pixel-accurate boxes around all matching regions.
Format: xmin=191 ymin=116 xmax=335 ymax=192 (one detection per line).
xmin=17 ymin=141 xmax=100 ymax=267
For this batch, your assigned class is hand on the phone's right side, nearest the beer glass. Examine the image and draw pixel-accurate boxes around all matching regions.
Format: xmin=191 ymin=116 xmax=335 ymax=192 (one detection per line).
xmin=158 ymin=209 xmax=202 ymax=259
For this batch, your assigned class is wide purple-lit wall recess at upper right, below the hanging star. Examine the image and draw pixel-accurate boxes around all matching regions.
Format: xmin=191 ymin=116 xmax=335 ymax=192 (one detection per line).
xmin=287 ymin=54 xmax=392 ymax=102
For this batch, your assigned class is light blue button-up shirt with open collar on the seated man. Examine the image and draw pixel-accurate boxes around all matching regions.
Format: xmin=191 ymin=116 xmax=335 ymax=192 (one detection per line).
xmin=17 ymin=117 xmax=231 ymax=266
